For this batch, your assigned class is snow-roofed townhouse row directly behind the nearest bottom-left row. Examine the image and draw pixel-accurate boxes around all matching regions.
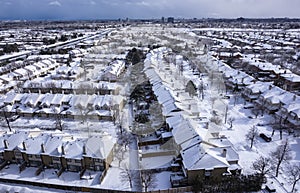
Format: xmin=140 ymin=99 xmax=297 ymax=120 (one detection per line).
xmin=0 ymin=92 xmax=124 ymax=120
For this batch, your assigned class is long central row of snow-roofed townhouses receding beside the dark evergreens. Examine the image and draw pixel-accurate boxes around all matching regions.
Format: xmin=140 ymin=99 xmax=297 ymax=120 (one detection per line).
xmin=144 ymin=48 xmax=241 ymax=186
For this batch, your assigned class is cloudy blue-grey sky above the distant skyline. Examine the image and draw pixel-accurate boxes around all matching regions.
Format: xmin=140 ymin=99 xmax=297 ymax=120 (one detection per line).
xmin=0 ymin=0 xmax=300 ymax=20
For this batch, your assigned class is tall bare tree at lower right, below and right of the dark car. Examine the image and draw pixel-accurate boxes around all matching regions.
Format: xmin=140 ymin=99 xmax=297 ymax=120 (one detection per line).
xmin=271 ymin=140 xmax=291 ymax=177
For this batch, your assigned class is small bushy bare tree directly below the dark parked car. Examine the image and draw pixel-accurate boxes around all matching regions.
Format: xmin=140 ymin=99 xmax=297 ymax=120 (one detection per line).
xmin=252 ymin=156 xmax=274 ymax=177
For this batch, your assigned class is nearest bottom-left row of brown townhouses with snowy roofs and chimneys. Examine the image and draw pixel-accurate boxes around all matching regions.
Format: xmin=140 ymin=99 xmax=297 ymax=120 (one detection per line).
xmin=0 ymin=130 xmax=116 ymax=179
